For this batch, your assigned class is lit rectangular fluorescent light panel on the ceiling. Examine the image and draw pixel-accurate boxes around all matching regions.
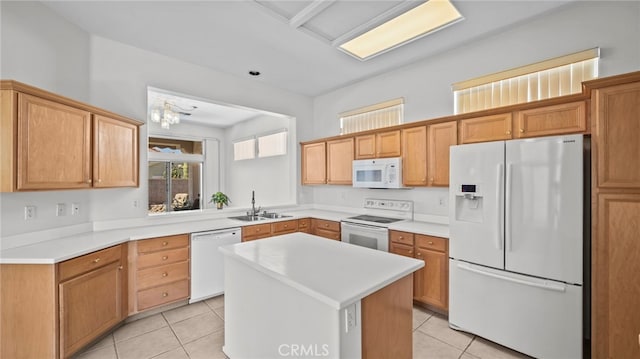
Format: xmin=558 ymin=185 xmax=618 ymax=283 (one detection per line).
xmin=340 ymin=0 xmax=463 ymax=60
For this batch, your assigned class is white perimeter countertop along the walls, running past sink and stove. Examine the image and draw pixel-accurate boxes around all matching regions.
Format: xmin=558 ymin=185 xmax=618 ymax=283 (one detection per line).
xmin=0 ymin=209 xmax=449 ymax=264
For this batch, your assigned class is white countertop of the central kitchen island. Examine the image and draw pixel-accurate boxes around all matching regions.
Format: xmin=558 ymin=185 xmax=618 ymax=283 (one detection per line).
xmin=220 ymin=232 xmax=424 ymax=310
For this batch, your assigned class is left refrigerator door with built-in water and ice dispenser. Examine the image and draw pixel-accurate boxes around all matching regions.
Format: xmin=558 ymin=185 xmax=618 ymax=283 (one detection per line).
xmin=449 ymin=141 xmax=504 ymax=269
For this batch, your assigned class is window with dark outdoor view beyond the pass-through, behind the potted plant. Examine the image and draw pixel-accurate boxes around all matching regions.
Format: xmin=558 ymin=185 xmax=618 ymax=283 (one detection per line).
xmin=148 ymin=137 xmax=204 ymax=213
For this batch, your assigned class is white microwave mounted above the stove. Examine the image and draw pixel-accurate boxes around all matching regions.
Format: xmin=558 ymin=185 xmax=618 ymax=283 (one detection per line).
xmin=353 ymin=157 xmax=403 ymax=188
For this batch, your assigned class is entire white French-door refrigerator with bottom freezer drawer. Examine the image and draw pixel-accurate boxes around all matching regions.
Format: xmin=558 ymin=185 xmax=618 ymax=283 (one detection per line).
xmin=449 ymin=135 xmax=584 ymax=359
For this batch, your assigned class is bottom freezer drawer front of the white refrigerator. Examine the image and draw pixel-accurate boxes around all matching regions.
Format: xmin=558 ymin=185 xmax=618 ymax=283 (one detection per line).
xmin=449 ymin=260 xmax=583 ymax=359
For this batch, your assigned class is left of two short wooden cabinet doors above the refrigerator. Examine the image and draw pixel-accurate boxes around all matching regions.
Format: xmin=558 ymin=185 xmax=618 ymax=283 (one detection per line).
xmin=460 ymin=113 xmax=511 ymax=143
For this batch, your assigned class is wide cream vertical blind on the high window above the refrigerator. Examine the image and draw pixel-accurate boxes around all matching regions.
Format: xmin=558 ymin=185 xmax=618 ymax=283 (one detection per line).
xmin=453 ymin=48 xmax=600 ymax=114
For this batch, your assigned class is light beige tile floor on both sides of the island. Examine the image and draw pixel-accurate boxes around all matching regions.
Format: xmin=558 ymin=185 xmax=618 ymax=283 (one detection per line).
xmin=75 ymin=296 xmax=528 ymax=359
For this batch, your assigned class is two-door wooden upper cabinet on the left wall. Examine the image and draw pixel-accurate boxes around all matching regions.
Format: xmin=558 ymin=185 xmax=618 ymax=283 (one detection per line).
xmin=0 ymin=81 xmax=140 ymax=192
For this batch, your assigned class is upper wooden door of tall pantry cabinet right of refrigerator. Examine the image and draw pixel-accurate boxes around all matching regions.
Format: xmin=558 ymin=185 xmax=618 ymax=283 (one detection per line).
xmin=592 ymin=83 xmax=640 ymax=188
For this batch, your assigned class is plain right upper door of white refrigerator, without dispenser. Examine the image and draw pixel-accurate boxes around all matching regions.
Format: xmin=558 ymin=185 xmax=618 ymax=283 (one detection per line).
xmin=505 ymin=135 xmax=583 ymax=284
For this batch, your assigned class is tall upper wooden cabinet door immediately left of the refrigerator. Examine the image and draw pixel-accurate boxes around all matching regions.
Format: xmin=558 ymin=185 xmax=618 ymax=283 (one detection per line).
xmin=427 ymin=121 xmax=458 ymax=186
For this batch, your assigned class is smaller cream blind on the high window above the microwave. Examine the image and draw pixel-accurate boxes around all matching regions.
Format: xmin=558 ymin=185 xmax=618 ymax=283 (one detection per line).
xmin=339 ymin=98 xmax=404 ymax=135
